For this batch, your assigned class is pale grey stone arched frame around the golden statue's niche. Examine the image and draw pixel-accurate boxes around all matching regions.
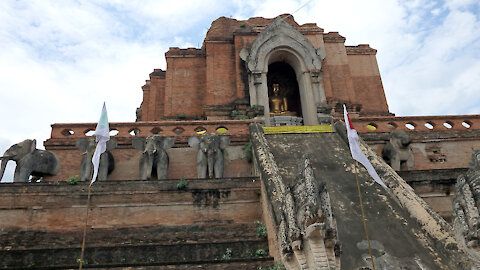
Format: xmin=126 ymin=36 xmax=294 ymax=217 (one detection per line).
xmin=240 ymin=18 xmax=325 ymax=125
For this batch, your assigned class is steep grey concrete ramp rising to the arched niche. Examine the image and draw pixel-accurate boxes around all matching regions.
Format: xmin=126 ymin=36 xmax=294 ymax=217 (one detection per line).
xmin=250 ymin=123 xmax=473 ymax=270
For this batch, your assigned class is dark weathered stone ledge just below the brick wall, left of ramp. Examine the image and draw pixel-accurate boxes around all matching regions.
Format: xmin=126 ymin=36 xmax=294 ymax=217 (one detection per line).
xmin=0 ymin=223 xmax=263 ymax=250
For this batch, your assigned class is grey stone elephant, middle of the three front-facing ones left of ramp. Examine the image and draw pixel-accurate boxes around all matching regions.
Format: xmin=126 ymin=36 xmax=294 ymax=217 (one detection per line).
xmin=132 ymin=135 xmax=174 ymax=180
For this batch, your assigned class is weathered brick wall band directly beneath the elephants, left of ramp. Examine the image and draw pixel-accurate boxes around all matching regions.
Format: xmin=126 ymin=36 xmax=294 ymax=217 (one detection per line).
xmin=0 ymin=178 xmax=261 ymax=231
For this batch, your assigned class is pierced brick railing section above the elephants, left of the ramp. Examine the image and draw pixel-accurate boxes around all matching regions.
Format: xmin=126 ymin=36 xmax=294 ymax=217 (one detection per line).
xmin=51 ymin=120 xmax=257 ymax=139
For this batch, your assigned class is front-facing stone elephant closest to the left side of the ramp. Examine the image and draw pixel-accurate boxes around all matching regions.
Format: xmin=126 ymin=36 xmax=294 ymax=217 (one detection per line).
xmin=188 ymin=133 xmax=230 ymax=178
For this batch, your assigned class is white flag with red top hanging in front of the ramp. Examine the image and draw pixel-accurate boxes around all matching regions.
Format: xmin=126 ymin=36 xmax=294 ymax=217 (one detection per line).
xmin=343 ymin=104 xmax=388 ymax=190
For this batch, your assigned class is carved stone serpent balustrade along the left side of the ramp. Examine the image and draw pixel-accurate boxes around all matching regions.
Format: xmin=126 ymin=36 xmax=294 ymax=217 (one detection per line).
xmin=250 ymin=125 xmax=341 ymax=270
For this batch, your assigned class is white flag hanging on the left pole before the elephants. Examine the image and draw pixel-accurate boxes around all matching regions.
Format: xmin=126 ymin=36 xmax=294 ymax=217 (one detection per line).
xmin=90 ymin=102 xmax=110 ymax=185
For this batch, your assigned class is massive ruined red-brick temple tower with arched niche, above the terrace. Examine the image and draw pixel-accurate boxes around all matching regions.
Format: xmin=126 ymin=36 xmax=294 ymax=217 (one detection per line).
xmin=141 ymin=14 xmax=391 ymax=125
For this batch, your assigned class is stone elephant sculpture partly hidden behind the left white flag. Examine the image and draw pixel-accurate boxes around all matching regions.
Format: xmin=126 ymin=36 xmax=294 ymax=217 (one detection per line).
xmin=75 ymin=135 xmax=117 ymax=181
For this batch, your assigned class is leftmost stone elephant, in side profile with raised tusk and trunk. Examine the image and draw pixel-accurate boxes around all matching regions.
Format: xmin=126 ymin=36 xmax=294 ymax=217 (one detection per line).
xmin=0 ymin=140 xmax=60 ymax=182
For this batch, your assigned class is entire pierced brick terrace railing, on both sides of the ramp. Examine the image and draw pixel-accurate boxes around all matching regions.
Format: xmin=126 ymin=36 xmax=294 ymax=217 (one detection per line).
xmin=47 ymin=115 xmax=480 ymax=140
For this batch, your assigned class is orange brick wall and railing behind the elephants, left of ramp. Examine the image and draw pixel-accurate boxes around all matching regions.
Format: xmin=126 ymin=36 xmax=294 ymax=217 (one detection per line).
xmin=44 ymin=120 xmax=253 ymax=181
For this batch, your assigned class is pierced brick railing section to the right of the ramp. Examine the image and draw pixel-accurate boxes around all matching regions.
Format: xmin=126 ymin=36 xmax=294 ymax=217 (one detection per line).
xmin=352 ymin=115 xmax=480 ymax=132
